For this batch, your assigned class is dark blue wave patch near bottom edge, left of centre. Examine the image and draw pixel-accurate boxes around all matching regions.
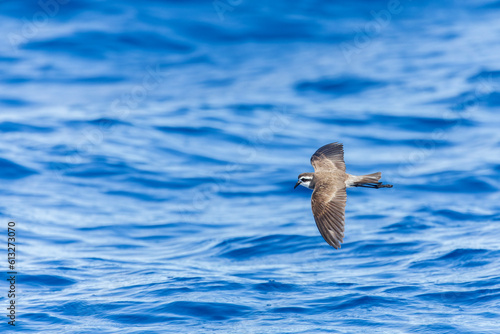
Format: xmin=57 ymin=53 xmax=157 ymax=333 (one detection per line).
xmin=151 ymin=301 xmax=253 ymax=321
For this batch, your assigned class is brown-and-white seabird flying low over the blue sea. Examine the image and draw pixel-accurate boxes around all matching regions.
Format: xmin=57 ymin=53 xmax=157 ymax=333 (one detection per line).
xmin=293 ymin=143 xmax=392 ymax=249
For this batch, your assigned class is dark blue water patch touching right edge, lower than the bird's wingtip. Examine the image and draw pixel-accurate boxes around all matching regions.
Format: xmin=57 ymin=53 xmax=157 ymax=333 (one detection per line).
xmin=410 ymin=248 xmax=499 ymax=269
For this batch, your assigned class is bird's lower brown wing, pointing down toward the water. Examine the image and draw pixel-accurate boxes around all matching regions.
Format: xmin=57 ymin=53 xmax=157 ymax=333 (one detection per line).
xmin=311 ymin=180 xmax=347 ymax=249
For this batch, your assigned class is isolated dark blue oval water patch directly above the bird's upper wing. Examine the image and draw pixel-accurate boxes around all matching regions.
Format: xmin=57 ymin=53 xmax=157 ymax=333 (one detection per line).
xmin=295 ymin=77 xmax=386 ymax=96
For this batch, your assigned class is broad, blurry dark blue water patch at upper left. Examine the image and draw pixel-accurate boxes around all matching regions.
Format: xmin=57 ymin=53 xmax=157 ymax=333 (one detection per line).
xmin=23 ymin=31 xmax=193 ymax=59
